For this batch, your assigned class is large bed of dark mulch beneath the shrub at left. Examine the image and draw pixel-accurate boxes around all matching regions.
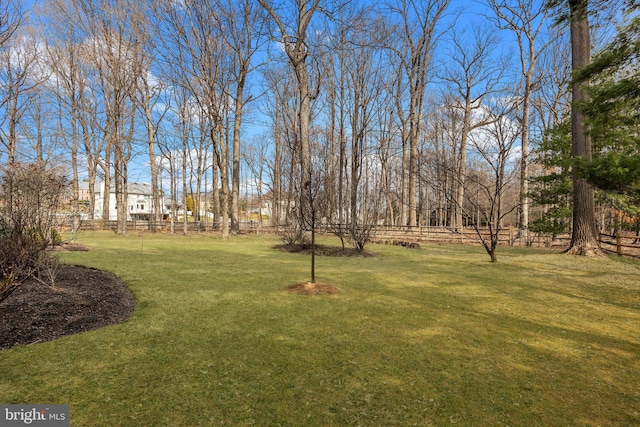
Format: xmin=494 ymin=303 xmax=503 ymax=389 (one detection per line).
xmin=0 ymin=268 xmax=135 ymax=349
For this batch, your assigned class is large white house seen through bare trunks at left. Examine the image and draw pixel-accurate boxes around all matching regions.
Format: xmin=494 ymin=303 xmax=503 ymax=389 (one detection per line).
xmin=80 ymin=182 xmax=164 ymax=221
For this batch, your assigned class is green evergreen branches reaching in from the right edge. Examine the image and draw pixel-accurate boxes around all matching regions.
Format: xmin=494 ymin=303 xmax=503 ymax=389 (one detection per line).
xmin=576 ymin=1 xmax=640 ymax=216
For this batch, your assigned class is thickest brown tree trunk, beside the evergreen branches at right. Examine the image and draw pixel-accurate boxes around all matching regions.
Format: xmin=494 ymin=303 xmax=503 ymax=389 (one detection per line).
xmin=568 ymin=0 xmax=599 ymax=255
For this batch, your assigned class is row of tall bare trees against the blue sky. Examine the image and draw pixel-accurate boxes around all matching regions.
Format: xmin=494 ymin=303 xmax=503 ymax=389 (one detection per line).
xmin=0 ymin=0 xmax=627 ymax=260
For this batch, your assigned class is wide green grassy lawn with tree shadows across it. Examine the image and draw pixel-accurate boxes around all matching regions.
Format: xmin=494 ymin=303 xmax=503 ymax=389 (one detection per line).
xmin=0 ymin=233 xmax=640 ymax=426
